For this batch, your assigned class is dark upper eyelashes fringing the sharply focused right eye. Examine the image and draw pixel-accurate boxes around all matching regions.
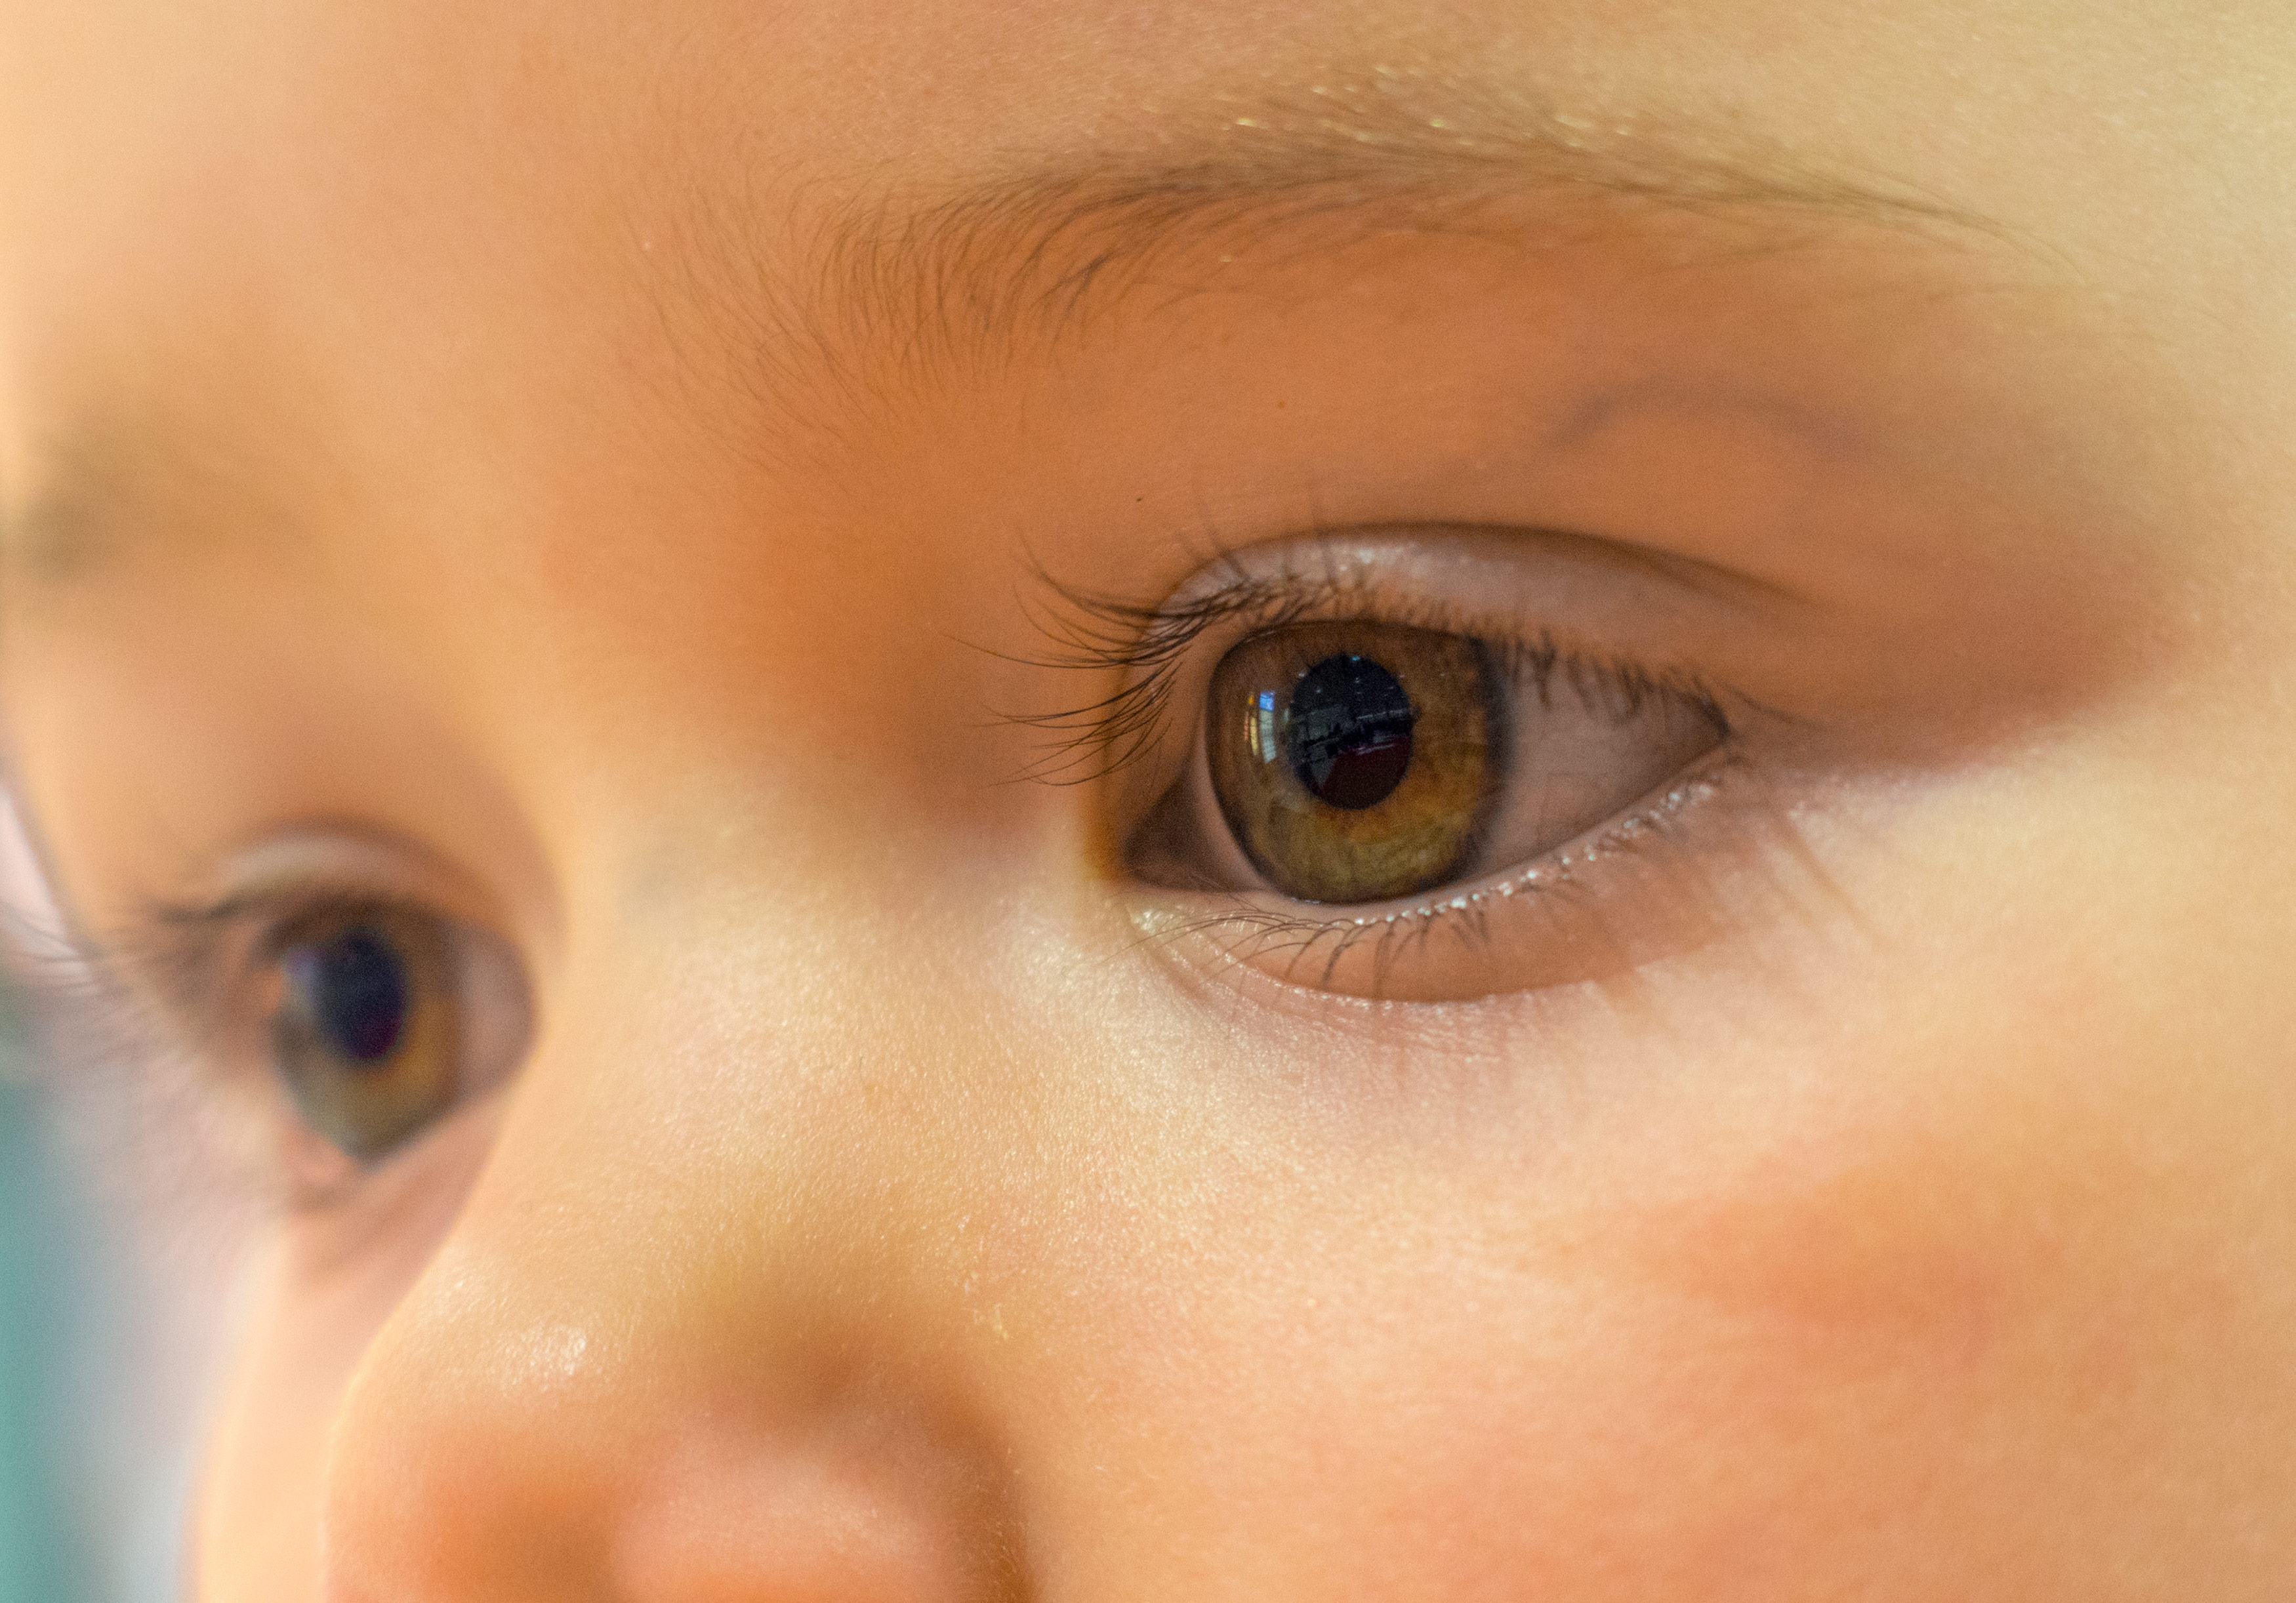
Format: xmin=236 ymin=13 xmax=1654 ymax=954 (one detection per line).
xmin=1004 ymin=537 xmax=1752 ymax=785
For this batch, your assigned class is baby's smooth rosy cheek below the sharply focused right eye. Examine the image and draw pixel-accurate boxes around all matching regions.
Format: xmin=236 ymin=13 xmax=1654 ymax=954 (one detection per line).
xmin=1047 ymin=992 xmax=2287 ymax=1603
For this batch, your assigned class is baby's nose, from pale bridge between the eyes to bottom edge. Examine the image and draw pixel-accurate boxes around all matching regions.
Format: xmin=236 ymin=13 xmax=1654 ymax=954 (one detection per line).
xmin=310 ymin=882 xmax=1047 ymax=1603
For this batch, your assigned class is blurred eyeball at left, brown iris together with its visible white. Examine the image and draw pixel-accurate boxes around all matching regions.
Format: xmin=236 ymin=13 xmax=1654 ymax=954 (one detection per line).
xmin=264 ymin=905 xmax=526 ymax=1162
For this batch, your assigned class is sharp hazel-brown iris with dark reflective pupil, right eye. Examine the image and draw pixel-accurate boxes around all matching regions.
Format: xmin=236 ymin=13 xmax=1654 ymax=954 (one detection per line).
xmin=1206 ymin=622 xmax=1506 ymax=903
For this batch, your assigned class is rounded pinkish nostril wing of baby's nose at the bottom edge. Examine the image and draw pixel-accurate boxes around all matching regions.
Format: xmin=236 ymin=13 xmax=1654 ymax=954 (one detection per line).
xmin=606 ymin=1417 xmax=1019 ymax=1603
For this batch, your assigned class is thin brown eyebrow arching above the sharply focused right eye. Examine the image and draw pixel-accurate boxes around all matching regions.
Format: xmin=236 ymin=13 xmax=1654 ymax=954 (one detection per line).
xmin=684 ymin=73 xmax=2048 ymax=411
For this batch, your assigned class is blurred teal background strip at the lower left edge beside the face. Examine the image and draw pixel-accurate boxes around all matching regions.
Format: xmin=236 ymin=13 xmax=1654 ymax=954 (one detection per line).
xmin=0 ymin=997 xmax=94 ymax=1603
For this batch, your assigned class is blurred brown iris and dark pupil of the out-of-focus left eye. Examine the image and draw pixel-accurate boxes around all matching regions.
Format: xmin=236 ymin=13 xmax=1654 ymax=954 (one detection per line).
xmin=271 ymin=907 xmax=471 ymax=1160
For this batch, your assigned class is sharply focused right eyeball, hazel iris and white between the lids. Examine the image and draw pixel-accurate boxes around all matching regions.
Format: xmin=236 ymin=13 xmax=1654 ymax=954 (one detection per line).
xmin=1132 ymin=618 xmax=1725 ymax=907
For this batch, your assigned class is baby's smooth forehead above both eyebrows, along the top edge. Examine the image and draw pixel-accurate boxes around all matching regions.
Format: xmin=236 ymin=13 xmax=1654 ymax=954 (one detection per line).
xmin=0 ymin=0 xmax=2296 ymax=537
